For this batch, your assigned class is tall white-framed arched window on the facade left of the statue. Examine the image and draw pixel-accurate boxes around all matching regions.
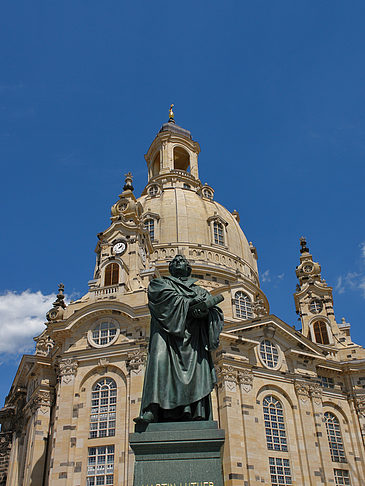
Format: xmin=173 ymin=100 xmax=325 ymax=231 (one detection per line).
xmin=90 ymin=378 xmax=117 ymax=439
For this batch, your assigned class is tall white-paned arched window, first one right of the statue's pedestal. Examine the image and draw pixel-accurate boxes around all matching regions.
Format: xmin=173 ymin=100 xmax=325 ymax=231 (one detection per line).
xmin=262 ymin=395 xmax=288 ymax=452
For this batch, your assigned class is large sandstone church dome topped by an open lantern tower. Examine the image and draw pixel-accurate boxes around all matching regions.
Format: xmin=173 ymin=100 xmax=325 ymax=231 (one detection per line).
xmin=138 ymin=122 xmax=259 ymax=287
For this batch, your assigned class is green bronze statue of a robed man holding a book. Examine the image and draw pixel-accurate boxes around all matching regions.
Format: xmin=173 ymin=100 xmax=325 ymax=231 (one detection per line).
xmin=135 ymin=255 xmax=223 ymax=423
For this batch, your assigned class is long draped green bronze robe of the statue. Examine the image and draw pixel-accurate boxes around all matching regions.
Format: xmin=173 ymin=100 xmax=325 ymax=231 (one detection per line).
xmin=141 ymin=276 xmax=223 ymax=414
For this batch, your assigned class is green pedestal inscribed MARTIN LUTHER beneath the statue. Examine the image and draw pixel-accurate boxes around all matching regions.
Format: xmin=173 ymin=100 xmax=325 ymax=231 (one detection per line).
xmin=129 ymin=421 xmax=224 ymax=486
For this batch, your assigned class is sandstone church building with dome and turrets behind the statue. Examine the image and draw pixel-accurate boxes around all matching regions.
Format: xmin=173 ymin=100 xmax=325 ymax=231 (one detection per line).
xmin=0 ymin=120 xmax=365 ymax=486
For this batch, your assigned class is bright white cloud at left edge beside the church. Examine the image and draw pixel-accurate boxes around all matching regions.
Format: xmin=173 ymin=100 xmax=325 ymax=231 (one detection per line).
xmin=0 ymin=290 xmax=56 ymax=354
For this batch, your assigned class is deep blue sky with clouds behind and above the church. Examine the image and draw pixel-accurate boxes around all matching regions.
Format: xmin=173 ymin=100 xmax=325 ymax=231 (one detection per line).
xmin=0 ymin=0 xmax=365 ymax=403
